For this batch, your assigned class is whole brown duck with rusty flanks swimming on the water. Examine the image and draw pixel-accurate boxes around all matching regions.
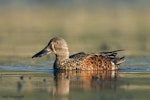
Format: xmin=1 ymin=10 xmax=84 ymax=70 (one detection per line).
xmin=32 ymin=37 xmax=125 ymax=71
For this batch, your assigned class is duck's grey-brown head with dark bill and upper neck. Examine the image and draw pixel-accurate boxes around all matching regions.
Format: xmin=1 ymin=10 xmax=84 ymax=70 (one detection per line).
xmin=32 ymin=37 xmax=69 ymax=59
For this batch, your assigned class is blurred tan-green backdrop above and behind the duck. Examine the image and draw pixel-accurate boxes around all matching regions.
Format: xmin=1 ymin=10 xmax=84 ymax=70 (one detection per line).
xmin=0 ymin=0 xmax=150 ymax=62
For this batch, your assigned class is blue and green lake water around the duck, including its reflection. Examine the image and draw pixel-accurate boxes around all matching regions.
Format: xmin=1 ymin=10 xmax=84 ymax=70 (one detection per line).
xmin=0 ymin=57 xmax=150 ymax=100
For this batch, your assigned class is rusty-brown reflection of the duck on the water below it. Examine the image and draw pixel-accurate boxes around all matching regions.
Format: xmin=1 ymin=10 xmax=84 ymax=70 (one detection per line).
xmin=53 ymin=71 xmax=118 ymax=100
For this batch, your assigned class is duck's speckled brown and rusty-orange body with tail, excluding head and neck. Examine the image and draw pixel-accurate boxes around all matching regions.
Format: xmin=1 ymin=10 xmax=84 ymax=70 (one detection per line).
xmin=55 ymin=51 xmax=124 ymax=70
